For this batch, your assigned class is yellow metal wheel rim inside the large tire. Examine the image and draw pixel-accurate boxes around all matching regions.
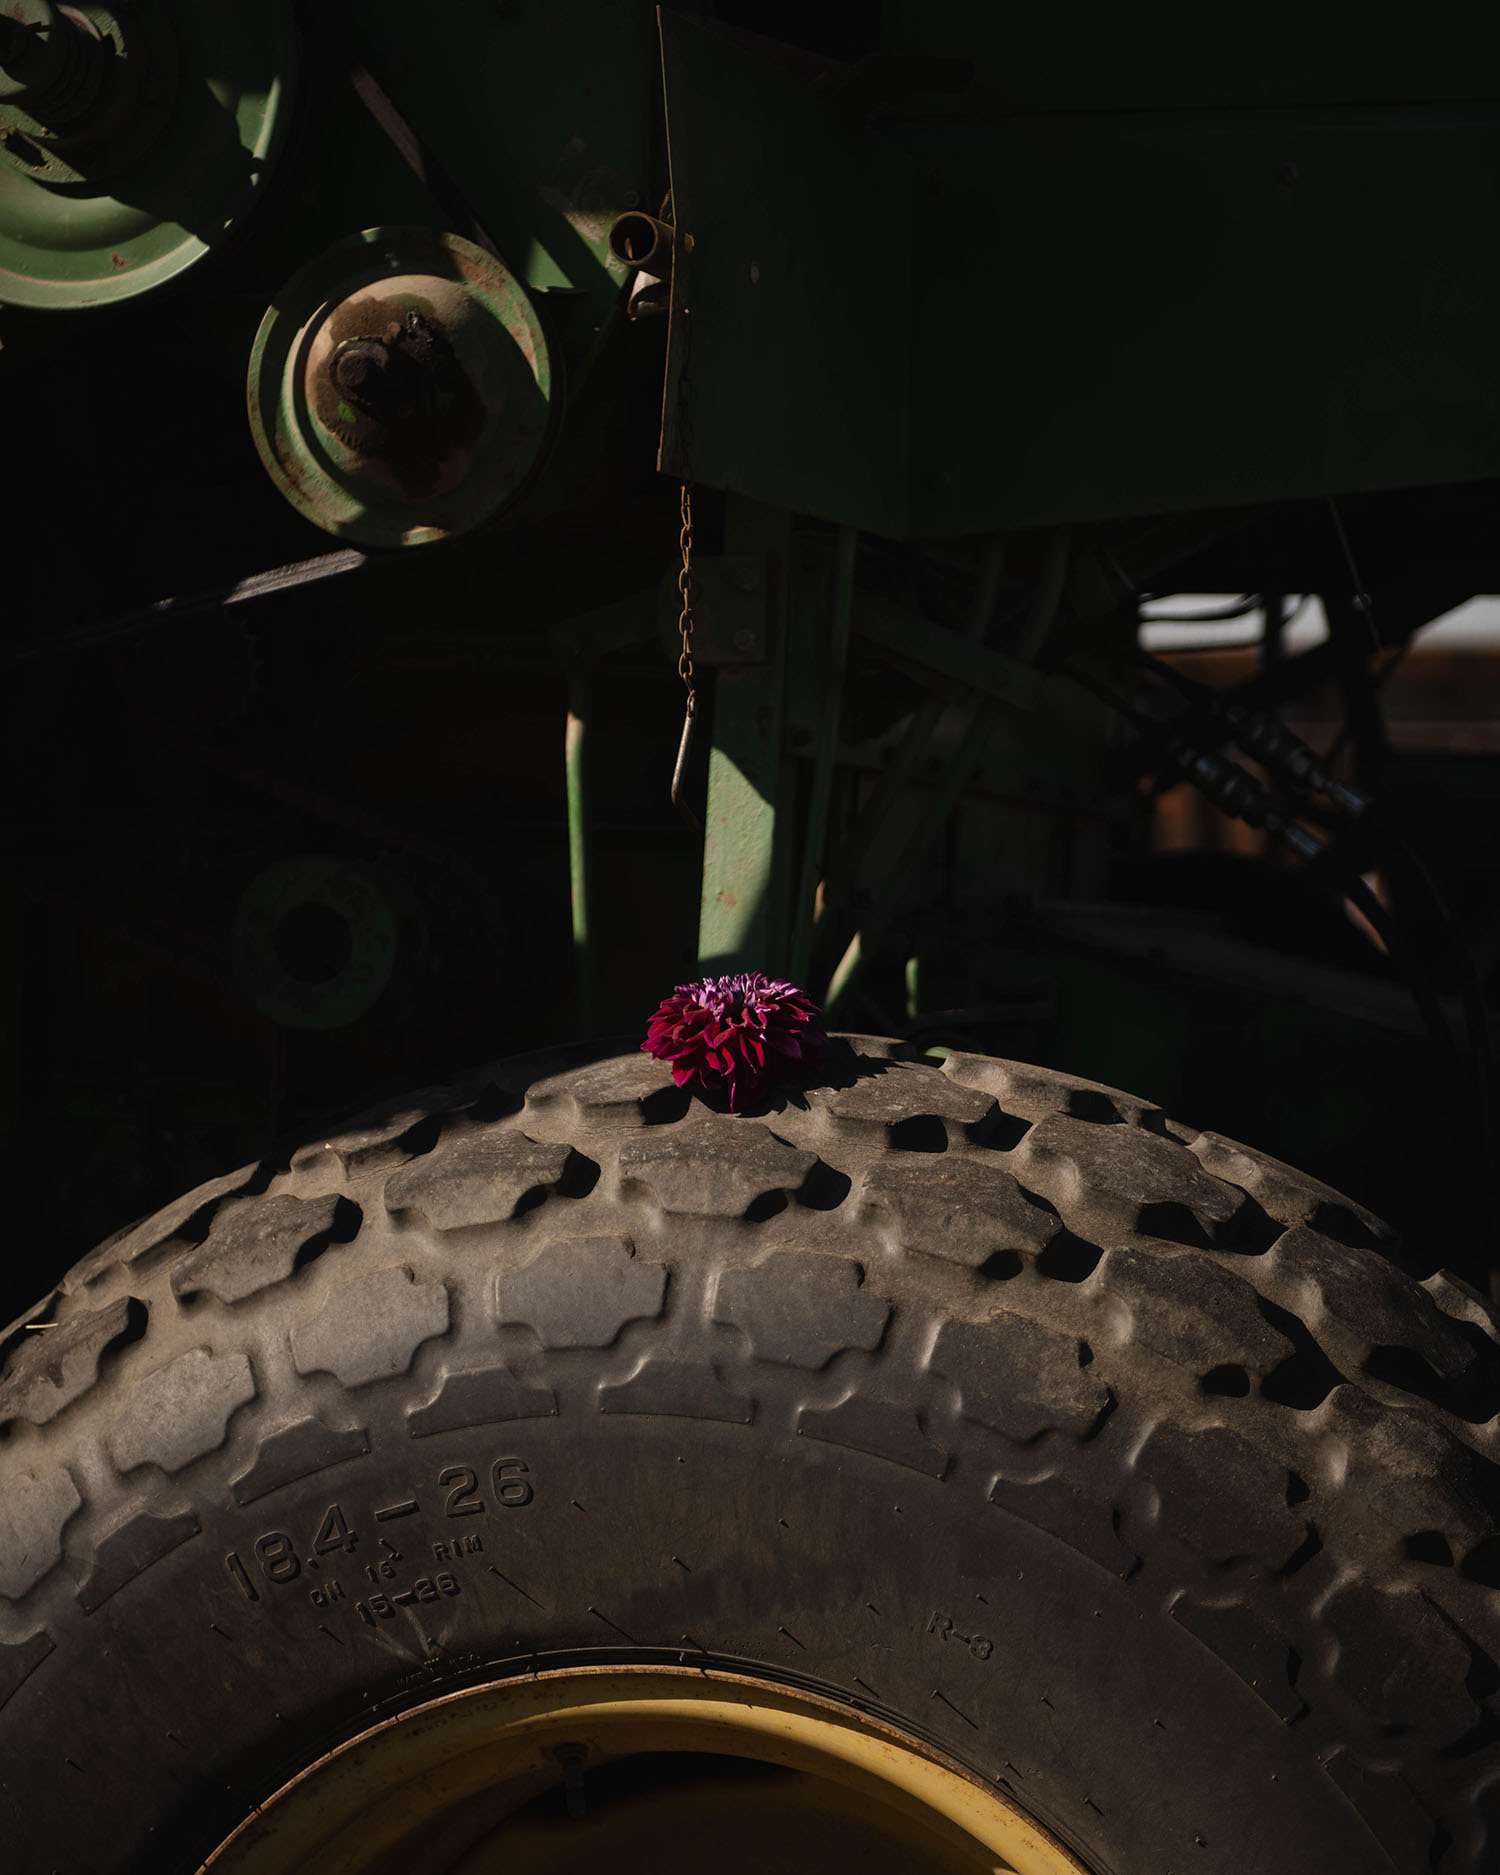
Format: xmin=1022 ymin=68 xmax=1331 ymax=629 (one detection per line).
xmin=203 ymin=1667 xmax=1086 ymax=1875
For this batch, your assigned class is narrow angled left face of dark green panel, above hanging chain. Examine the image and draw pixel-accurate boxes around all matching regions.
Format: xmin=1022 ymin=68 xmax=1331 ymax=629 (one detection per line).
xmin=662 ymin=13 xmax=911 ymax=534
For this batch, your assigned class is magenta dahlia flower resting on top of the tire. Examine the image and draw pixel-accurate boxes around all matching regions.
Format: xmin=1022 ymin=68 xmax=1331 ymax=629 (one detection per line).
xmin=641 ymin=969 xmax=829 ymax=1112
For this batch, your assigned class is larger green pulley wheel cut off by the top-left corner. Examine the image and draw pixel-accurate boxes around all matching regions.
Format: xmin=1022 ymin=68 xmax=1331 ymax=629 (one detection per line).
xmin=0 ymin=0 xmax=298 ymax=311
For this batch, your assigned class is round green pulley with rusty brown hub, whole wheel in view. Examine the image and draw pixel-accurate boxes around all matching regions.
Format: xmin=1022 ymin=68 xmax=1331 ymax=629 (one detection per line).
xmin=249 ymin=227 xmax=553 ymax=548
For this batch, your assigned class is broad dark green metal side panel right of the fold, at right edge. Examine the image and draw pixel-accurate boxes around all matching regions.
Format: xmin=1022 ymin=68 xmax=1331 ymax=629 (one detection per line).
xmin=906 ymin=105 xmax=1500 ymax=536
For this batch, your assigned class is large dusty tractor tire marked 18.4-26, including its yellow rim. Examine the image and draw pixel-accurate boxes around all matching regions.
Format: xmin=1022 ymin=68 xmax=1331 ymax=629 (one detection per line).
xmin=0 ymin=1037 xmax=1500 ymax=1875
